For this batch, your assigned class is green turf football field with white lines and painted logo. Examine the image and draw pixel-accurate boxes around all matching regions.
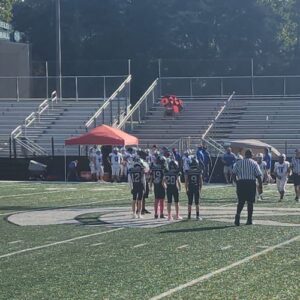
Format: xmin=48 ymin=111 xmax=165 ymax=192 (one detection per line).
xmin=0 ymin=182 xmax=300 ymax=300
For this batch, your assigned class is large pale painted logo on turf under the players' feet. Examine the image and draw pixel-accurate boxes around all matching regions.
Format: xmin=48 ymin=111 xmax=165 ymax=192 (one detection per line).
xmin=8 ymin=206 xmax=300 ymax=228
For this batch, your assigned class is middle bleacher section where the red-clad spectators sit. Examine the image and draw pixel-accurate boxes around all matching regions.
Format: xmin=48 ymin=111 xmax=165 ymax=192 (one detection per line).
xmin=131 ymin=96 xmax=228 ymax=148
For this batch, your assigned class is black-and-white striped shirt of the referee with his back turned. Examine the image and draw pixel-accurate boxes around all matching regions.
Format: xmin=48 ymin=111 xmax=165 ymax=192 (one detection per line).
xmin=232 ymin=158 xmax=262 ymax=180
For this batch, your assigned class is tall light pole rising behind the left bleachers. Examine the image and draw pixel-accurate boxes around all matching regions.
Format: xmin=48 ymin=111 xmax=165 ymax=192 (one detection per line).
xmin=55 ymin=0 xmax=62 ymax=100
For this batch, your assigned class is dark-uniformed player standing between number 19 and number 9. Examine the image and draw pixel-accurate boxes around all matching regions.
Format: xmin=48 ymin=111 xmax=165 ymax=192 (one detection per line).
xmin=164 ymin=160 xmax=182 ymax=221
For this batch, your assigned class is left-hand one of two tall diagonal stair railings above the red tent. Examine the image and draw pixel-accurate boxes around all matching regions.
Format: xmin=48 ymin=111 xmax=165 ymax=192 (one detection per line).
xmin=85 ymin=75 xmax=131 ymax=130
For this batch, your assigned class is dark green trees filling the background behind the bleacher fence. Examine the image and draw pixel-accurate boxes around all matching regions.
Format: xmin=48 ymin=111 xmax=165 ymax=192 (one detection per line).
xmin=8 ymin=0 xmax=300 ymax=88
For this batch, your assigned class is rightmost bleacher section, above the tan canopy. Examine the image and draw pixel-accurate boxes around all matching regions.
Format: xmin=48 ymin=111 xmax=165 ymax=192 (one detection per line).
xmin=209 ymin=96 xmax=300 ymax=156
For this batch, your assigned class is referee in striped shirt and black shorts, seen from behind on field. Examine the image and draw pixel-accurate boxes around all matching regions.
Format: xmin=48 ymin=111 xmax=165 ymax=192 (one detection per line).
xmin=232 ymin=149 xmax=262 ymax=226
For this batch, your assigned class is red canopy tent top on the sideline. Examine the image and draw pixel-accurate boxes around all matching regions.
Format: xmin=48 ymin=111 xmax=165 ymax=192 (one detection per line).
xmin=65 ymin=125 xmax=139 ymax=146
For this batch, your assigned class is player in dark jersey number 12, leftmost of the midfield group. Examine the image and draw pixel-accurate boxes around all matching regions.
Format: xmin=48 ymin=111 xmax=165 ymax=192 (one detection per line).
xmin=128 ymin=159 xmax=146 ymax=219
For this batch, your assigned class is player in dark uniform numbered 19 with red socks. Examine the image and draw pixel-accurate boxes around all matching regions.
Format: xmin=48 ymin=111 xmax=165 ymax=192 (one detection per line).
xmin=150 ymin=156 xmax=166 ymax=219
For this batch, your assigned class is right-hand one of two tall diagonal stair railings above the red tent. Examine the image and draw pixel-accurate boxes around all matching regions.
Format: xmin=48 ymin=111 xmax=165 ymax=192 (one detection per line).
xmin=117 ymin=79 xmax=160 ymax=131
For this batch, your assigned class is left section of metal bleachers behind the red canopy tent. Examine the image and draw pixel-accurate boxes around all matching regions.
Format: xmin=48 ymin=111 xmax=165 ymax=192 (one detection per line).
xmin=0 ymin=76 xmax=131 ymax=157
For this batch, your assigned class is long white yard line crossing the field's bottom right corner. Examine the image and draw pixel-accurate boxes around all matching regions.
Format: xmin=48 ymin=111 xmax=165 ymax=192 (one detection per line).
xmin=150 ymin=235 xmax=300 ymax=300
